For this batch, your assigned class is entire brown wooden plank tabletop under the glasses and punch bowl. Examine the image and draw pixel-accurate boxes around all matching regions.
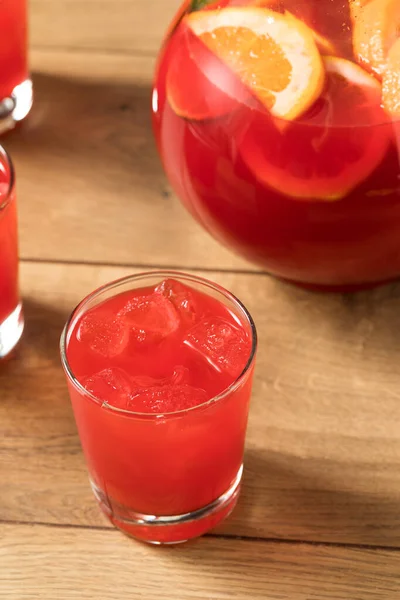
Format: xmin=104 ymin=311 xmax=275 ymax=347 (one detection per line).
xmin=0 ymin=0 xmax=400 ymax=600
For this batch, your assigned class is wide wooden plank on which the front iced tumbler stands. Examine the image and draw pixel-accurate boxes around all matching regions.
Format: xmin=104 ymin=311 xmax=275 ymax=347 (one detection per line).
xmin=0 ymin=263 xmax=400 ymax=546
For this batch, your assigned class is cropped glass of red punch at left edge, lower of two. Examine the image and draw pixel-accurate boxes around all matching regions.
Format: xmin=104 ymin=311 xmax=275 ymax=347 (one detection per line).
xmin=0 ymin=147 xmax=24 ymax=359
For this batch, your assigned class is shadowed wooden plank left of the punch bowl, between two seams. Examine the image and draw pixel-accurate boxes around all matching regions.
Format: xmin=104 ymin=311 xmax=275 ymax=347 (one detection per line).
xmin=5 ymin=51 xmax=255 ymax=270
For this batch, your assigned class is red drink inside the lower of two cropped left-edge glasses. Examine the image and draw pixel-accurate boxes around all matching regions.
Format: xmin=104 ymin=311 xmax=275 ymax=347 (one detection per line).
xmin=0 ymin=169 xmax=19 ymax=324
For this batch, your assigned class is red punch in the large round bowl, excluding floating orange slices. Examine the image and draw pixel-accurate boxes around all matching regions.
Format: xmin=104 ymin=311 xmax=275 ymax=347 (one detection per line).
xmin=153 ymin=0 xmax=400 ymax=289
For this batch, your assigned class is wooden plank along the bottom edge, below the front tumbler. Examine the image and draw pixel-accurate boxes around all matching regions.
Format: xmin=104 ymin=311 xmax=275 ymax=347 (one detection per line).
xmin=0 ymin=525 xmax=400 ymax=600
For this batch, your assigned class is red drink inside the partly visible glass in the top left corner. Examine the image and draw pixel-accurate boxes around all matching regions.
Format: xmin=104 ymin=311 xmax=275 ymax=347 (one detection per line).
xmin=0 ymin=0 xmax=28 ymax=101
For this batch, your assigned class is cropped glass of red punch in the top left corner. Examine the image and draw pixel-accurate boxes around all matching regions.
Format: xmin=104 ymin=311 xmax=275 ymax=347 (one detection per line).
xmin=0 ymin=0 xmax=32 ymax=133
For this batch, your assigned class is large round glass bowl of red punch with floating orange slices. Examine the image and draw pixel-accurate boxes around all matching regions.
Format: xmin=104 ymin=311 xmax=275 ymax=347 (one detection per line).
xmin=153 ymin=0 xmax=400 ymax=290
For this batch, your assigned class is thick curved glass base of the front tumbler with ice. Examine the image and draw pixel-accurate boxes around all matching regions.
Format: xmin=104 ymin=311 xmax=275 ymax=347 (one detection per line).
xmin=90 ymin=466 xmax=243 ymax=545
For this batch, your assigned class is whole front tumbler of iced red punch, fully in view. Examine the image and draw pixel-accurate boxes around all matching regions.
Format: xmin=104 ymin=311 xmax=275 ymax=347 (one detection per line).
xmin=61 ymin=272 xmax=256 ymax=544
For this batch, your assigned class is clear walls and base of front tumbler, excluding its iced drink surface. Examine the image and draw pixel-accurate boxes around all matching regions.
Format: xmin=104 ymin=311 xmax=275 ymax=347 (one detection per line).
xmin=61 ymin=271 xmax=257 ymax=544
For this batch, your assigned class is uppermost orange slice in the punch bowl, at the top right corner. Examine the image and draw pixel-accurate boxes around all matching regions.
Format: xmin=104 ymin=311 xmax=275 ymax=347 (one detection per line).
xmin=353 ymin=0 xmax=400 ymax=75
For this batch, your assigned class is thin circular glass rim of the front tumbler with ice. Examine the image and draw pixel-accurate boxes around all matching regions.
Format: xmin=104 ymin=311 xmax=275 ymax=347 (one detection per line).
xmin=60 ymin=269 xmax=258 ymax=420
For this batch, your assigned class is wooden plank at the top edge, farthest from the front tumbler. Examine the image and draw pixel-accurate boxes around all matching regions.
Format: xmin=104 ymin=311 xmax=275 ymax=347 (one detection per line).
xmin=30 ymin=0 xmax=181 ymax=55
